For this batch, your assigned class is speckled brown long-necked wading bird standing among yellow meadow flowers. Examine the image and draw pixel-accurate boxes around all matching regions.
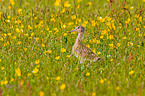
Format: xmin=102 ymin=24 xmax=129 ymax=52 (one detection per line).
xmin=68 ymin=25 xmax=101 ymax=63
